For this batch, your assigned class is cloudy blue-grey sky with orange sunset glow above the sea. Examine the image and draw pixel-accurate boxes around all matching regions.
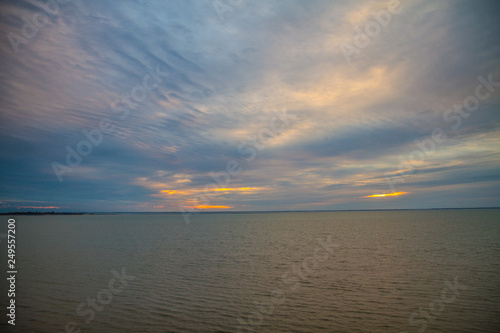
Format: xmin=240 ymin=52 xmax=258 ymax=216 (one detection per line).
xmin=0 ymin=0 xmax=500 ymax=212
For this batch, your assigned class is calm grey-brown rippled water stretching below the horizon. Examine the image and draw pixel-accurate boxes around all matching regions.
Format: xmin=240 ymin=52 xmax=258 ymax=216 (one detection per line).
xmin=0 ymin=210 xmax=500 ymax=333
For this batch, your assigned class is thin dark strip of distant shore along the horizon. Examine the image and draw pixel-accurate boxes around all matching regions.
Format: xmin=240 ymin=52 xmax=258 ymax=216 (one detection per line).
xmin=0 ymin=207 xmax=500 ymax=215
